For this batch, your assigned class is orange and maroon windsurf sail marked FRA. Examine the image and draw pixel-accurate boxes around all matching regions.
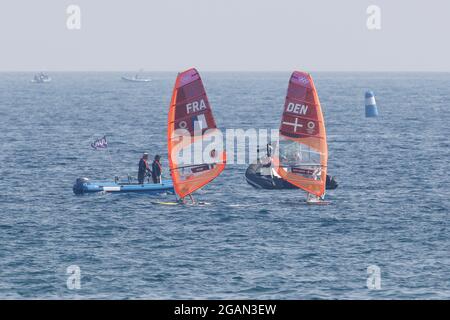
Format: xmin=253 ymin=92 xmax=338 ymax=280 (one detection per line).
xmin=167 ymin=68 xmax=226 ymax=198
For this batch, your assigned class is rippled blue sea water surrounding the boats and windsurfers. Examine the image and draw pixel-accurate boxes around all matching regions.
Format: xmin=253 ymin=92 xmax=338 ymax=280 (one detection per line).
xmin=0 ymin=70 xmax=450 ymax=299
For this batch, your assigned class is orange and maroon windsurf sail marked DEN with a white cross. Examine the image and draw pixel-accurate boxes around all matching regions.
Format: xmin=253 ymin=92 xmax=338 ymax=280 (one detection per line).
xmin=273 ymin=71 xmax=328 ymax=196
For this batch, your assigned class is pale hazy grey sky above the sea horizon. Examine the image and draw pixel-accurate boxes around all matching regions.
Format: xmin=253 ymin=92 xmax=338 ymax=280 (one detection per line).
xmin=0 ymin=0 xmax=450 ymax=71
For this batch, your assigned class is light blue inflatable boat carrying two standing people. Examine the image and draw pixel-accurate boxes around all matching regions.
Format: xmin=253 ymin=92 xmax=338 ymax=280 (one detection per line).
xmin=73 ymin=178 xmax=174 ymax=194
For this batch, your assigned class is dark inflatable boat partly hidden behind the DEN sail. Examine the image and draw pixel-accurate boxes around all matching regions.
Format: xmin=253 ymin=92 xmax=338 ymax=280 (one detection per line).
xmin=245 ymin=163 xmax=338 ymax=190
